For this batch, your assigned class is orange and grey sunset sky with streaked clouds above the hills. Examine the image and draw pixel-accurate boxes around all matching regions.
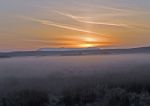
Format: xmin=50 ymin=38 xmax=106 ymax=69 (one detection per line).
xmin=0 ymin=0 xmax=150 ymax=51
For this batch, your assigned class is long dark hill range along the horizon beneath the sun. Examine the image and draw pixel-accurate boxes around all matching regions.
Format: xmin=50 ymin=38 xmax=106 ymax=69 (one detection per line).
xmin=0 ymin=47 xmax=150 ymax=58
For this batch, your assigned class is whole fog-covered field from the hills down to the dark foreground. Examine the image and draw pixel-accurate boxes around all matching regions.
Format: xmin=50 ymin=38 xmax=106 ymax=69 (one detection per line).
xmin=0 ymin=53 xmax=150 ymax=106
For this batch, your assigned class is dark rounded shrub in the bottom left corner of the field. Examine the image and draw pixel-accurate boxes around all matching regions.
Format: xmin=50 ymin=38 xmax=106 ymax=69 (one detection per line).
xmin=2 ymin=90 xmax=49 ymax=106
